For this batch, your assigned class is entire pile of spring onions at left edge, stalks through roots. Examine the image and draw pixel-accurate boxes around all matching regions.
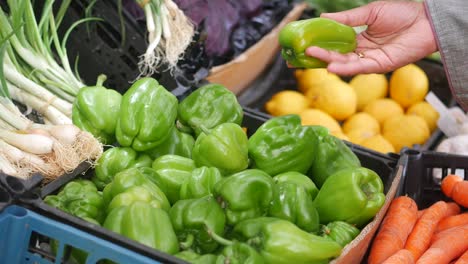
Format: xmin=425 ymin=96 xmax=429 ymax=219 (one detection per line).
xmin=0 ymin=0 xmax=103 ymax=181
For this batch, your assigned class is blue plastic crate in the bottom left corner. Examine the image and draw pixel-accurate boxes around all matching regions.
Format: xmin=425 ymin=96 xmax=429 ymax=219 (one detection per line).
xmin=0 ymin=205 xmax=160 ymax=264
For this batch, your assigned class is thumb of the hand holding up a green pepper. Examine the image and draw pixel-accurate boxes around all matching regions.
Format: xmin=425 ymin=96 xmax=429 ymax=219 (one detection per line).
xmin=320 ymin=3 xmax=375 ymax=27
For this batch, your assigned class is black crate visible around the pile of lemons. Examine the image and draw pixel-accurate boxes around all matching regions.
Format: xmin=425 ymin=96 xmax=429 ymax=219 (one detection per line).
xmin=238 ymin=54 xmax=456 ymax=150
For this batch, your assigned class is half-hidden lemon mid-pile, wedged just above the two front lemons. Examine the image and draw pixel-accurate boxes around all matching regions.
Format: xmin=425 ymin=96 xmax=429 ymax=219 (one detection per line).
xmin=364 ymin=98 xmax=405 ymax=125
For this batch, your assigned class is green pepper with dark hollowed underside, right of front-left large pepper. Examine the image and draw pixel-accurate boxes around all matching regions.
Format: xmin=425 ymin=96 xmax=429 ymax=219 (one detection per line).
xmin=169 ymin=196 xmax=226 ymax=253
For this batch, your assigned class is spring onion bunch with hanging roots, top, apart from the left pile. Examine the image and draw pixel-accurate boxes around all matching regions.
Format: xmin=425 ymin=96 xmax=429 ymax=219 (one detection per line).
xmin=135 ymin=0 xmax=195 ymax=75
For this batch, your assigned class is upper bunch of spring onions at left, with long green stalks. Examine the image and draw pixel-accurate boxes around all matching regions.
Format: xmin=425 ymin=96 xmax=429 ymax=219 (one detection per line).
xmin=0 ymin=0 xmax=100 ymax=112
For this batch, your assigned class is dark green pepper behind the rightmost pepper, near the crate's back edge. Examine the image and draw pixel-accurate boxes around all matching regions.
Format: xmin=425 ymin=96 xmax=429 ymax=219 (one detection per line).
xmin=307 ymin=135 xmax=361 ymax=188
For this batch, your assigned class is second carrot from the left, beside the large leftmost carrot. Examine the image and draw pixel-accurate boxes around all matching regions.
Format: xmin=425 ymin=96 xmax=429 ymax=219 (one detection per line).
xmin=405 ymin=201 xmax=453 ymax=261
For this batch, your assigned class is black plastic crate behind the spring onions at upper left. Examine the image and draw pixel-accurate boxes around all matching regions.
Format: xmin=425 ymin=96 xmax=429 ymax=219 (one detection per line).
xmin=54 ymin=0 xmax=194 ymax=97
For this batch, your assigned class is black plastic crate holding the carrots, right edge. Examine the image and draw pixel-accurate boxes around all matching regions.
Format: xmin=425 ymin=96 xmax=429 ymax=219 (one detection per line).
xmin=397 ymin=149 xmax=468 ymax=209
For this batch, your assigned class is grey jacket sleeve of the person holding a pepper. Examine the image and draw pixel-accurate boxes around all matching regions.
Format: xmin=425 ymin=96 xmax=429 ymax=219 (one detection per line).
xmin=425 ymin=0 xmax=468 ymax=111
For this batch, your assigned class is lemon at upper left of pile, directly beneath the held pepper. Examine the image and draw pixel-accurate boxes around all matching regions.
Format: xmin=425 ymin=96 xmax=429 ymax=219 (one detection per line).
xmin=294 ymin=68 xmax=340 ymax=93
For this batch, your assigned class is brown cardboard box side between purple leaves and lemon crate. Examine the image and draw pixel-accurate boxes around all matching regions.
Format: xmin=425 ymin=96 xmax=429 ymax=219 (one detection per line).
xmin=206 ymin=3 xmax=307 ymax=94
